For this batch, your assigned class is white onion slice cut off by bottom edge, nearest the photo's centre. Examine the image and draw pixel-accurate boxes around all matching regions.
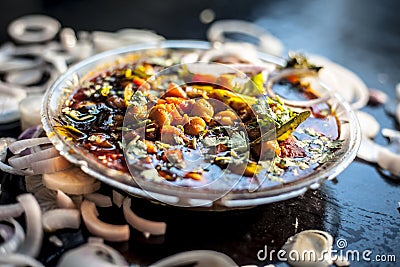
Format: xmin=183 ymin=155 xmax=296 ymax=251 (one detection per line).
xmin=151 ymin=250 xmax=238 ymax=267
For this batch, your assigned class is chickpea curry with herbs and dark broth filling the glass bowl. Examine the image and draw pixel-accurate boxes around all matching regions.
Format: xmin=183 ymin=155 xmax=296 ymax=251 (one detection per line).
xmin=58 ymin=52 xmax=341 ymax=186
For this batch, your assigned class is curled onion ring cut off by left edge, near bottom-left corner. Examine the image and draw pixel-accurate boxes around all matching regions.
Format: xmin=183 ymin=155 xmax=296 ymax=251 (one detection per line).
xmin=0 ymin=219 xmax=25 ymax=255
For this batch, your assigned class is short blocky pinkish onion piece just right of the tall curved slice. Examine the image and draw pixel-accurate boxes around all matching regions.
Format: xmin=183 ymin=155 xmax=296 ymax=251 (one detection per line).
xmin=43 ymin=209 xmax=81 ymax=232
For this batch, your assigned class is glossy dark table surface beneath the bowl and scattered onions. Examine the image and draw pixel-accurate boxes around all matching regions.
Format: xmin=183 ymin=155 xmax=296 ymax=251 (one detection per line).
xmin=0 ymin=0 xmax=400 ymax=266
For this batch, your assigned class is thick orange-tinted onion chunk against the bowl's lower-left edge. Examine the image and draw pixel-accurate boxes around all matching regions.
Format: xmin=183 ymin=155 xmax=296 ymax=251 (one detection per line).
xmin=43 ymin=167 xmax=100 ymax=195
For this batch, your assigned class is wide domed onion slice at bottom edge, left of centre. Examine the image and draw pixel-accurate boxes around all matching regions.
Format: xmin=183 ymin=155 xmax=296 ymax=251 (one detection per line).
xmin=57 ymin=242 xmax=128 ymax=267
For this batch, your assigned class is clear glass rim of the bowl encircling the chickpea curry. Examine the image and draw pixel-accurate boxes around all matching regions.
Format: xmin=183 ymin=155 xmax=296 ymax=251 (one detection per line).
xmin=42 ymin=40 xmax=361 ymax=210
